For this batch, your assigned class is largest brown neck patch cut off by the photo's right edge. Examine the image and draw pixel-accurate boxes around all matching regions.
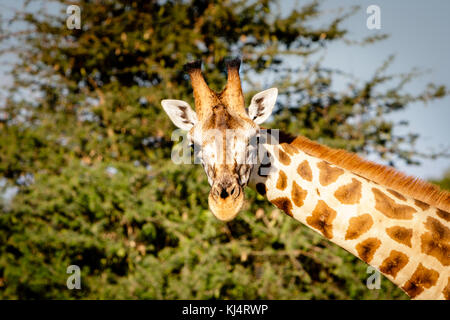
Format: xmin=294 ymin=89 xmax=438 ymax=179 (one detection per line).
xmin=420 ymin=217 xmax=450 ymax=266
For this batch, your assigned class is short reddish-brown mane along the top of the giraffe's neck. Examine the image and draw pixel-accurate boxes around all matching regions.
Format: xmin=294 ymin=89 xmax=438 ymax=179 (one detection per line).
xmin=280 ymin=132 xmax=450 ymax=212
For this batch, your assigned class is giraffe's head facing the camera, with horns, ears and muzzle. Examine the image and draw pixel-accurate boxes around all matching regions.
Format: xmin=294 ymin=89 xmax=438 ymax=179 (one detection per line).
xmin=161 ymin=59 xmax=278 ymax=221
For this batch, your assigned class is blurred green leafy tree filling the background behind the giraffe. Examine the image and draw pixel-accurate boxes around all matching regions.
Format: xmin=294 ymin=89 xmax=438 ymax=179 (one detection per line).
xmin=0 ymin=0 xmax=447 ymax=298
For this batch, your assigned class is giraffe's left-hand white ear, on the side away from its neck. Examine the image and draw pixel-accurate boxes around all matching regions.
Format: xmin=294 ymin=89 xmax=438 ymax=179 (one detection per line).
xmin=161 ymin=99 xmax=198 ymax=131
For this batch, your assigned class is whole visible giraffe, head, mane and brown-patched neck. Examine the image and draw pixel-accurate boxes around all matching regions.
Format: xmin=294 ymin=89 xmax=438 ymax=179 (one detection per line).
xmin=161 ymin=59 xmax=450 ymax=300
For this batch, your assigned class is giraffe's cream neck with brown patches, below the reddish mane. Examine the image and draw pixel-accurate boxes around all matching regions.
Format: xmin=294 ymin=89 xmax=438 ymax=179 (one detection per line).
xmin=249 ymin=133 xmax=450 ymax=299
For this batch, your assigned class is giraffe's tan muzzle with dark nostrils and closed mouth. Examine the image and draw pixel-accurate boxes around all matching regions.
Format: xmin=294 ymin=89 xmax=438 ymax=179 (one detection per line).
xmin=208 ymin=183 xmax=244 ymax=222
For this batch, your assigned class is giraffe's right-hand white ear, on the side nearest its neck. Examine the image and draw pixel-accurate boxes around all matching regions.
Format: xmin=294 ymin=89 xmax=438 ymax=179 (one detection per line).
xmin=248 ymin=88 xmax=278 ymax=124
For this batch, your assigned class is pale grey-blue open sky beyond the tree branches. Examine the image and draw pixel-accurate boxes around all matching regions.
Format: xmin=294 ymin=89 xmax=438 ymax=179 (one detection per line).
xmin=0 ymin=0 xmax=450 ymax=179
